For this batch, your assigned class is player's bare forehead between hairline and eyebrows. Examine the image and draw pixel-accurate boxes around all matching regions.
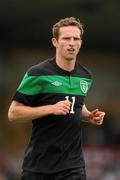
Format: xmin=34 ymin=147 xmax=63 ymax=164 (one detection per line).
xmin=59 ymin=26 xmax=81 ymax=36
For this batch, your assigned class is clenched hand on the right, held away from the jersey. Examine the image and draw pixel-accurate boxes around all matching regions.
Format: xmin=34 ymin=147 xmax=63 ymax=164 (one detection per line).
xmin=88 ymin=109 xmax=105 ymax=125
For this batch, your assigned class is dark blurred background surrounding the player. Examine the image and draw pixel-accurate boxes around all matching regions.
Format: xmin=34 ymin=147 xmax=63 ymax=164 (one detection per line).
xmin=0 ymin=0 xmax=120 ymax=180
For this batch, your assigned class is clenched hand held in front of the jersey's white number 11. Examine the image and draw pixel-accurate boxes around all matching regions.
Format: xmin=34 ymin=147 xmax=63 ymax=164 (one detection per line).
xmin=52 ymin=100 xmax=71 ymax=115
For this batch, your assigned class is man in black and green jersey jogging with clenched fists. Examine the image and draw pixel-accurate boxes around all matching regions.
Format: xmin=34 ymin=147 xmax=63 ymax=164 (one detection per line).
xmin=8 ymin=17 xmax=105 ymax=180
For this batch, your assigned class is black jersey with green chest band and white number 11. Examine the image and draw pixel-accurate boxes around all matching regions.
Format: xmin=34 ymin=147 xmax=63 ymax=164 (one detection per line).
xmin=13 ymin=58 xmax=92 ymax=173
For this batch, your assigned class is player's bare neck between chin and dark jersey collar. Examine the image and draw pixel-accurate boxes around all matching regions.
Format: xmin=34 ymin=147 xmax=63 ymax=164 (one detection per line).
xmin=56 ymin=57 xmax=75 ymax=71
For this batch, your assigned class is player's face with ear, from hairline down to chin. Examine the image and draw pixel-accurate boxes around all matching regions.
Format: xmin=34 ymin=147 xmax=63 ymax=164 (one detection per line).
xmin=52 ymin=26 xmax=82 ymax=61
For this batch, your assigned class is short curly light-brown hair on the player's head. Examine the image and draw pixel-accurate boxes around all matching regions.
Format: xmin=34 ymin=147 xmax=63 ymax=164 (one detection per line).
xmin=52 ymin=17 xmax=84 ymax=39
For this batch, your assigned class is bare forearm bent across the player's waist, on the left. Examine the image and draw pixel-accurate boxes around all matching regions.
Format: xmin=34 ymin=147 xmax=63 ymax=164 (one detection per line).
xmin=8 ymin=101 xmax=53 ymax=122
